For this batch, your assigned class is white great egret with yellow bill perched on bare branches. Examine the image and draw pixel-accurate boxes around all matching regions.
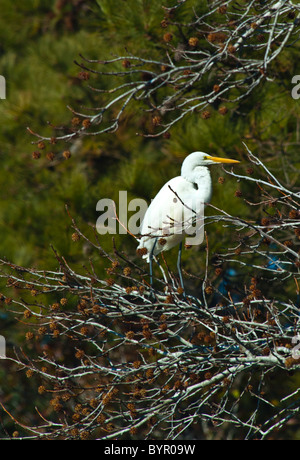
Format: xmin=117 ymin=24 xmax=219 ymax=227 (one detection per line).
xmin=137 ymin=152 xmax=239 ymax=288
